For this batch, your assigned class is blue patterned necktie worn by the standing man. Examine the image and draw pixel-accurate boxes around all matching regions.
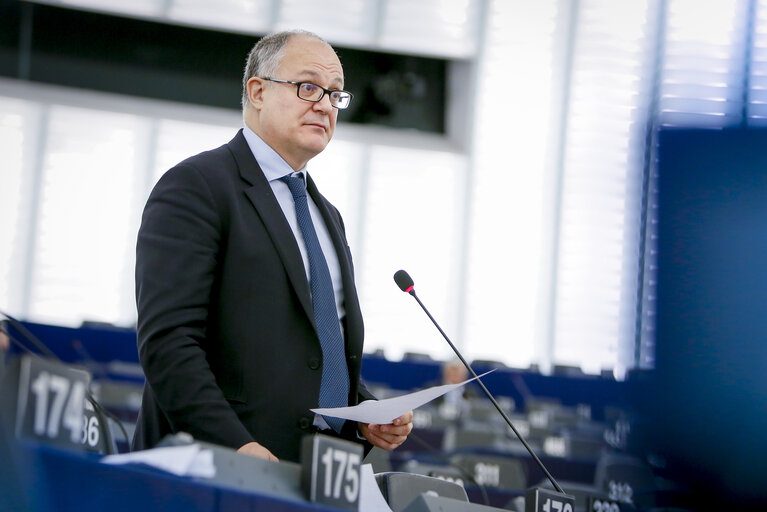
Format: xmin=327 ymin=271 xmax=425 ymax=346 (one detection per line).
xmin=280 ymin=175 xmax=349 ymax=432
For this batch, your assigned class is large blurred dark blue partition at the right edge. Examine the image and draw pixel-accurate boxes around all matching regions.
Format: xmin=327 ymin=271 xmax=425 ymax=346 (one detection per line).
xmin=646 ymin=130 xmax=767 ymax=510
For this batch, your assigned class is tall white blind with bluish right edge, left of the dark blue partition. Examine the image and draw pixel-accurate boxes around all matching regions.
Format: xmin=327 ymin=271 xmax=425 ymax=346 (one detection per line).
xmin=552 ymin=0 xmax=655 ymax=373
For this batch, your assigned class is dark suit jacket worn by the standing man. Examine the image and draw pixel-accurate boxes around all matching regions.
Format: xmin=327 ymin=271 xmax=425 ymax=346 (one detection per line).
xmin=133 ymin=131 xmax=372 ymax=461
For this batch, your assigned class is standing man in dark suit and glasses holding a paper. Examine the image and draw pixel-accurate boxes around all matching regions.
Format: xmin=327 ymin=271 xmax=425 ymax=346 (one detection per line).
xmin=133 ymin=31 xmax=412 ymax=461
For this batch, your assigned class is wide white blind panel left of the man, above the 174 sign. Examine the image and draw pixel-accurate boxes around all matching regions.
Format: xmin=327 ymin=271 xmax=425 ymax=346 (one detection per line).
xmin=29 ymin=106 xmax=148 ymax=325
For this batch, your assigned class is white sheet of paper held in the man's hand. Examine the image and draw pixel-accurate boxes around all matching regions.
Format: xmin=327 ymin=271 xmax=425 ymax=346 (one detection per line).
xmin=311 ymin=370 xmax=495 ymax=425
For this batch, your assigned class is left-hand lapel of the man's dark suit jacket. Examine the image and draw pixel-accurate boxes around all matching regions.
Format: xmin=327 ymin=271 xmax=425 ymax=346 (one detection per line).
xmin=229 ymin=130 xmax=314 ymax=325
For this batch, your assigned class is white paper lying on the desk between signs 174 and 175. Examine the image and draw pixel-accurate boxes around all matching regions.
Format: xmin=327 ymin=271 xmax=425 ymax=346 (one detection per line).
xmin=101 ymin=444 xmax=216 ymax=478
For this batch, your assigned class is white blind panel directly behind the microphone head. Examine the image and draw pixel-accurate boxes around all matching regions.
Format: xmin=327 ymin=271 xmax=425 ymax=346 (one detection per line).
xmin=356 ymin=145 xmax=465 ymax=358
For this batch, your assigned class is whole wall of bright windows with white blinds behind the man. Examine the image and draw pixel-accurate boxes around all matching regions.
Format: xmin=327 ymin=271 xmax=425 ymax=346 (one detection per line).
xmin=0 ymin=0 xmax=767 ymax=376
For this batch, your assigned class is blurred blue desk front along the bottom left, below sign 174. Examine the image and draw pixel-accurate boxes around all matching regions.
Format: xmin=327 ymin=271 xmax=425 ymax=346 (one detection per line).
xmin=0 ymin=441 xmax=344 ymax=512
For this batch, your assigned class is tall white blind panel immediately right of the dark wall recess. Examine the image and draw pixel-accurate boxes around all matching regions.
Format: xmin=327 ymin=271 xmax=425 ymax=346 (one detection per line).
xmin=459 ymin=0 xmax=558 ymax=367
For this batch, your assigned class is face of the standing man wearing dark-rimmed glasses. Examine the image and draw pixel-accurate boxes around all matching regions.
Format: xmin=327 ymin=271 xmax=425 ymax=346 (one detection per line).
xmin=249 ymin=35 xmax=344 ymax=170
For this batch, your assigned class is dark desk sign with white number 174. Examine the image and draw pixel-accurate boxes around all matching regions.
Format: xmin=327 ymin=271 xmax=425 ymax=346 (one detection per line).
xmin=16 ymin=356 xmax=90 ymax=449
